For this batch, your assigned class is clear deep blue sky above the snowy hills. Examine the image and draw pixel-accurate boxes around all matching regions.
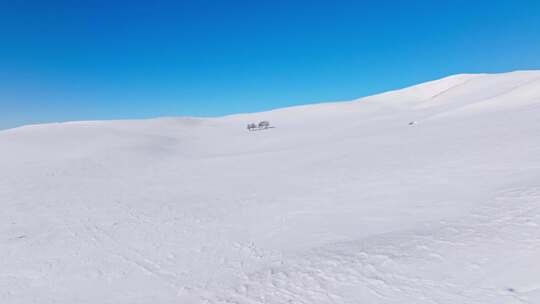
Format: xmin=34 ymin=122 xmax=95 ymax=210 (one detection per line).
xmin=0 ymin=0 xmax=540 ymax=128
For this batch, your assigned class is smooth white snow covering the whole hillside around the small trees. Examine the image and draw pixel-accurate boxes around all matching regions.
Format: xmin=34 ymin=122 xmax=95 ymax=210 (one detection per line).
xmin=0 ymin=71 xmax=540 ymax=304
